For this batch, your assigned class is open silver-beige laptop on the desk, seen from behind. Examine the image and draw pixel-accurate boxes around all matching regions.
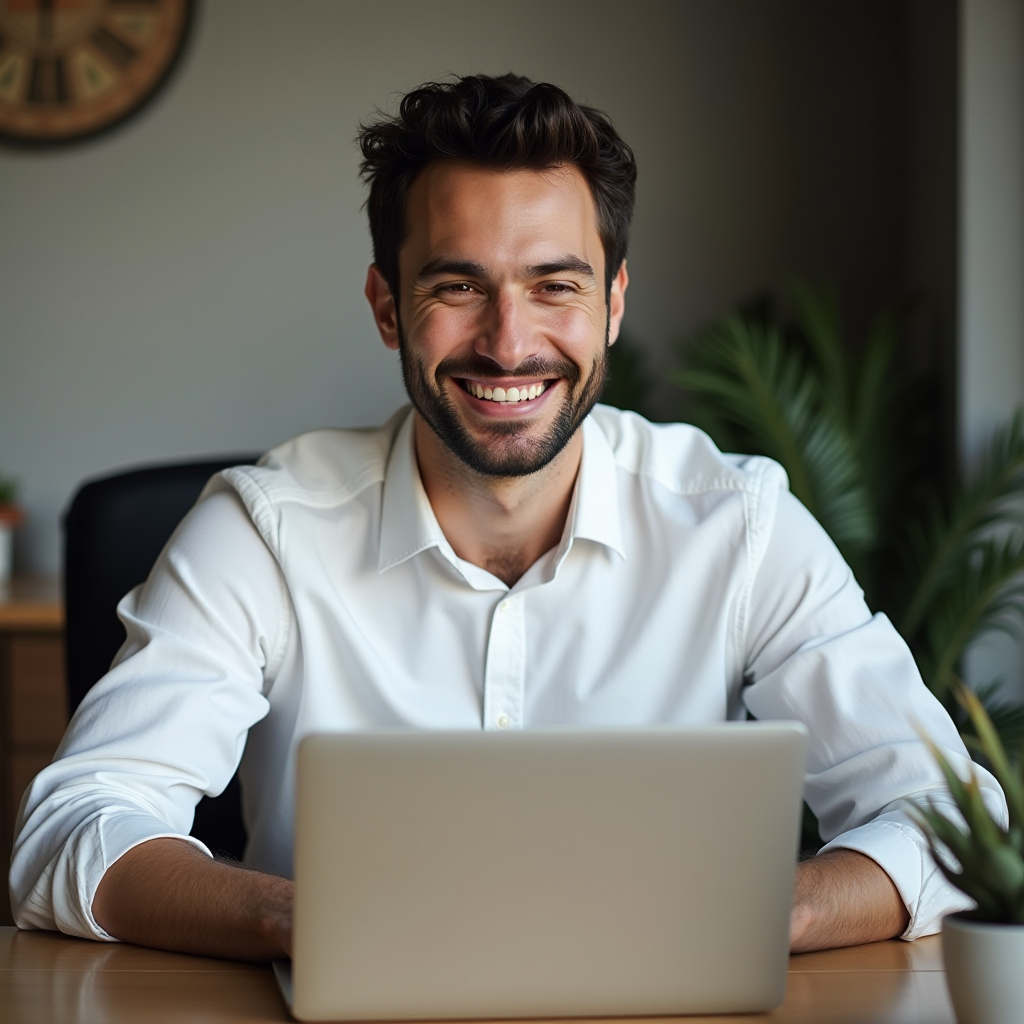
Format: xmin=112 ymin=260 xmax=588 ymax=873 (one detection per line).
xmin=275 ymin=723 xmax=806 ymax=1021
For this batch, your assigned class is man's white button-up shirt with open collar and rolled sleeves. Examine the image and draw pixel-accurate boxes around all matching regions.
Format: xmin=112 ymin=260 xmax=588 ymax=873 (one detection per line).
xmin=10 ymin=407 xmax=1005 ymax=938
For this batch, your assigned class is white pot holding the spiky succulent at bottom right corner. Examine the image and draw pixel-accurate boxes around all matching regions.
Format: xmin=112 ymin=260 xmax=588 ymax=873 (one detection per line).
xmin=942 ymin=913 xmax=1024 ymax=1024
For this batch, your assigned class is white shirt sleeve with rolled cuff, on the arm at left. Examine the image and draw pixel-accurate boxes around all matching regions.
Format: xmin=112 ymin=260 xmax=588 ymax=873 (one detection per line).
xmin=10 ymin=484 xmax=288 ymax=939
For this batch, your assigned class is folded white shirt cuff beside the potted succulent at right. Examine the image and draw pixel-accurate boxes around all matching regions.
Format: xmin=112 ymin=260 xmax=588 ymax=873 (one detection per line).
xmin=820 ymin=818 xmax=974 ymax=939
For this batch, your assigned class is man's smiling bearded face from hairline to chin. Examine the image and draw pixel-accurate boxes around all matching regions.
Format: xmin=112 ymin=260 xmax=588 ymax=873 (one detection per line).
xmin=368 ymin=162 xmax=626 ymax=476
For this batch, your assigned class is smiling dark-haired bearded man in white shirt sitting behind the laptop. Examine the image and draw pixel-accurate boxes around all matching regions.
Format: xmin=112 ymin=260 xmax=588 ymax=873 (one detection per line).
xmin=11 ymin=76 xmax=1005 ymax=958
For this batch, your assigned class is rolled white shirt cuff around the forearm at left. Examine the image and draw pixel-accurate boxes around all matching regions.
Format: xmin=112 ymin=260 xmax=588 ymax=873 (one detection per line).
xmin=16 ymin=810 xmax=213 ymax=942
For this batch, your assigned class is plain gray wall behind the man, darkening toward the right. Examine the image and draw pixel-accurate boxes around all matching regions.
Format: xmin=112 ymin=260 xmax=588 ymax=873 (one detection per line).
xmin=0 ymin=0 xmax=952 ymax=571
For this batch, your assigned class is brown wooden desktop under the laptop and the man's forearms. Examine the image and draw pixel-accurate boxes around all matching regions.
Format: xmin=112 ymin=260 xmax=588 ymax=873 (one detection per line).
xmin=0 ymin=928 xmax=954 ymax=1024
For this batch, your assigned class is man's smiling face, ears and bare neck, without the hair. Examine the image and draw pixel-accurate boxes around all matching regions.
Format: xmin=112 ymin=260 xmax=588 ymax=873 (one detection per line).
xmin=367 ymin=160 xmax=632 ymax=587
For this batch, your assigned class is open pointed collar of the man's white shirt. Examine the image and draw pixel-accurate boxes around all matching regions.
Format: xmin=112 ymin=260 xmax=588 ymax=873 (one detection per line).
xmin=377 ymin=410 xmax=626 ymax=572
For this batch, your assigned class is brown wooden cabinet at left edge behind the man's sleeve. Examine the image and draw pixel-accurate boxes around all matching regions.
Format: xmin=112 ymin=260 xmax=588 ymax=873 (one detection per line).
xmin=0 ymin=580 xmax=68 ymax=925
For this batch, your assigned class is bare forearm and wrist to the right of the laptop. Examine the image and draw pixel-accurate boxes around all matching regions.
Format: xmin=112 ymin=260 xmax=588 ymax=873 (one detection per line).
xmin=790 ymin=850 xmax=910 ymax=953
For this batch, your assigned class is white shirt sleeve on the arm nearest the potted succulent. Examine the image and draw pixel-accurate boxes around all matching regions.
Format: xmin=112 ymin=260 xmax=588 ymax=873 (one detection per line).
xmin=743 ymin=489 xmax=1007 ymax=939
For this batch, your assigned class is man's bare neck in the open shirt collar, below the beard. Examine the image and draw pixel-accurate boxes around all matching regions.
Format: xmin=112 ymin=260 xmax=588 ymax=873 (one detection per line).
xmin=414 ymin=413 xmax=583 ymax=587
